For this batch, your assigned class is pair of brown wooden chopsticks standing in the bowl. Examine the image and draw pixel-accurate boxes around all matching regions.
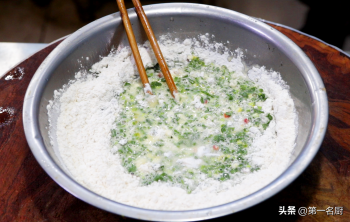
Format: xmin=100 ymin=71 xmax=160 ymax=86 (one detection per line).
xmin=116 ymin=0 xmax=177 ymax=98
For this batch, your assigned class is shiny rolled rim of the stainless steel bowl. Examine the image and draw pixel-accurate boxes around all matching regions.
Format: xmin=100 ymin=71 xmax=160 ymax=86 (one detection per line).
xmin=23 ymin=3 xmax=328 ymax=221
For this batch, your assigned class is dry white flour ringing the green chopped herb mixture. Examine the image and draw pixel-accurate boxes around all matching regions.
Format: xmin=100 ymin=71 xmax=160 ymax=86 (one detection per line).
xmin=48 ymin=35 xmax=297 ymax=210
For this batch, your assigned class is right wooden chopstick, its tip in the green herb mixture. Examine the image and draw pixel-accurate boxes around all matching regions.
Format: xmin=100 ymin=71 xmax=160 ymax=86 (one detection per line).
xmin=132 ymin=0 xmax=177 ymax=98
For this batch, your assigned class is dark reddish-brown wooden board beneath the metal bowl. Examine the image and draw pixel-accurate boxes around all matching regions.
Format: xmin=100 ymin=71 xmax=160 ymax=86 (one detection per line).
xmin=0 ymin=24 xmax=350 ymax=221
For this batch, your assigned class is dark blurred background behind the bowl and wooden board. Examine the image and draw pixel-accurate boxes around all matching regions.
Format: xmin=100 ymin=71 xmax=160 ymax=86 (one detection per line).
xmin=0 ymin=0 xmax=350 ymax=50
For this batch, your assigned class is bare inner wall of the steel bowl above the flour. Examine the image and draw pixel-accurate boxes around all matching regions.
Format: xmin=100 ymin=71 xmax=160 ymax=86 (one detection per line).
xmin=39 ymin=4 xmax=312 ymax=165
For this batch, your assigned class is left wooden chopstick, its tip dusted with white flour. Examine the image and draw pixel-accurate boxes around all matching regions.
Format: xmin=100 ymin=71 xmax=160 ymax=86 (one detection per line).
xmin=116 ymin=0 xmax=152 ymax=95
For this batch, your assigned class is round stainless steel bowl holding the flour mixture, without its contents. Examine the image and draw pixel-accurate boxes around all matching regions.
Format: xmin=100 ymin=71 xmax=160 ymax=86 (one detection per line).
xmin=23 ymin=3 xmax=328 ymax=221
